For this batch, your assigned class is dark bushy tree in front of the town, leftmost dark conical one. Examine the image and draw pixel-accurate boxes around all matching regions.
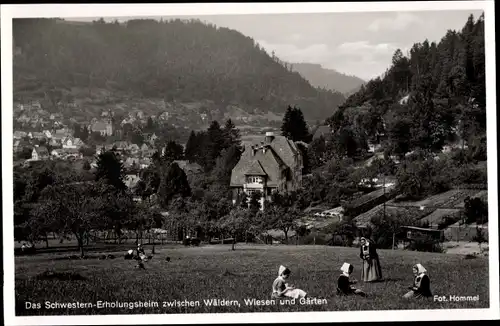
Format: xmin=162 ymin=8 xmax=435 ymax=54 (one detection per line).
xmin=95 ymin=151 xmax=127 ymax=191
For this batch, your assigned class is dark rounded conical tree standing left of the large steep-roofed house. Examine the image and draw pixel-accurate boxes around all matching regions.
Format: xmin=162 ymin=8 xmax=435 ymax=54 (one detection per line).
xmin=158 ymin=163 xmax=191 ymax=208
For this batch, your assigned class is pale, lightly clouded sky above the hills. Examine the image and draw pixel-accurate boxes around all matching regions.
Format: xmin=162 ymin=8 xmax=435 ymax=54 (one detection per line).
xmin=72 ymin=10 xmax=482 ymax=80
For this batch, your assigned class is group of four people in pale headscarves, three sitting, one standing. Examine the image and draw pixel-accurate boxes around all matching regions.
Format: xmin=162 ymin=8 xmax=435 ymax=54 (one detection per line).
xmin=272 ymin=238 xmax=432 ymax=299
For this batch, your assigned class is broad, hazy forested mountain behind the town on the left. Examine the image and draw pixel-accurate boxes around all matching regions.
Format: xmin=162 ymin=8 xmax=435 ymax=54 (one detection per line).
xmin=13 ymin=19 xmax=344 ymax=119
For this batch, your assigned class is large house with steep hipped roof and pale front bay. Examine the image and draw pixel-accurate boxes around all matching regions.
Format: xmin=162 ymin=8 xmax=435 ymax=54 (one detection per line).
xmin=231 ymin=132 xmax=303 ymax=209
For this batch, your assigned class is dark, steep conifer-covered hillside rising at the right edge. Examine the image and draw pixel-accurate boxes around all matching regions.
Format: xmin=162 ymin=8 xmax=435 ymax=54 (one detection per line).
xmin=327 ymin=15 xmax=486 ymax=156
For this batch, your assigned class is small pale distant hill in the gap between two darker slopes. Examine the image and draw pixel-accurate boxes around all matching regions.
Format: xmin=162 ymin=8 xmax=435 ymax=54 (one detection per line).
xmin=291 ymin=63 xmax=365 ymax=95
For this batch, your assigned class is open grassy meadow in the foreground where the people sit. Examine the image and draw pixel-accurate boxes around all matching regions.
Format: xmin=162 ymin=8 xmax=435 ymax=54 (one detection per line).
xmin=15 ymin=244 xmax=489 ymax=315
